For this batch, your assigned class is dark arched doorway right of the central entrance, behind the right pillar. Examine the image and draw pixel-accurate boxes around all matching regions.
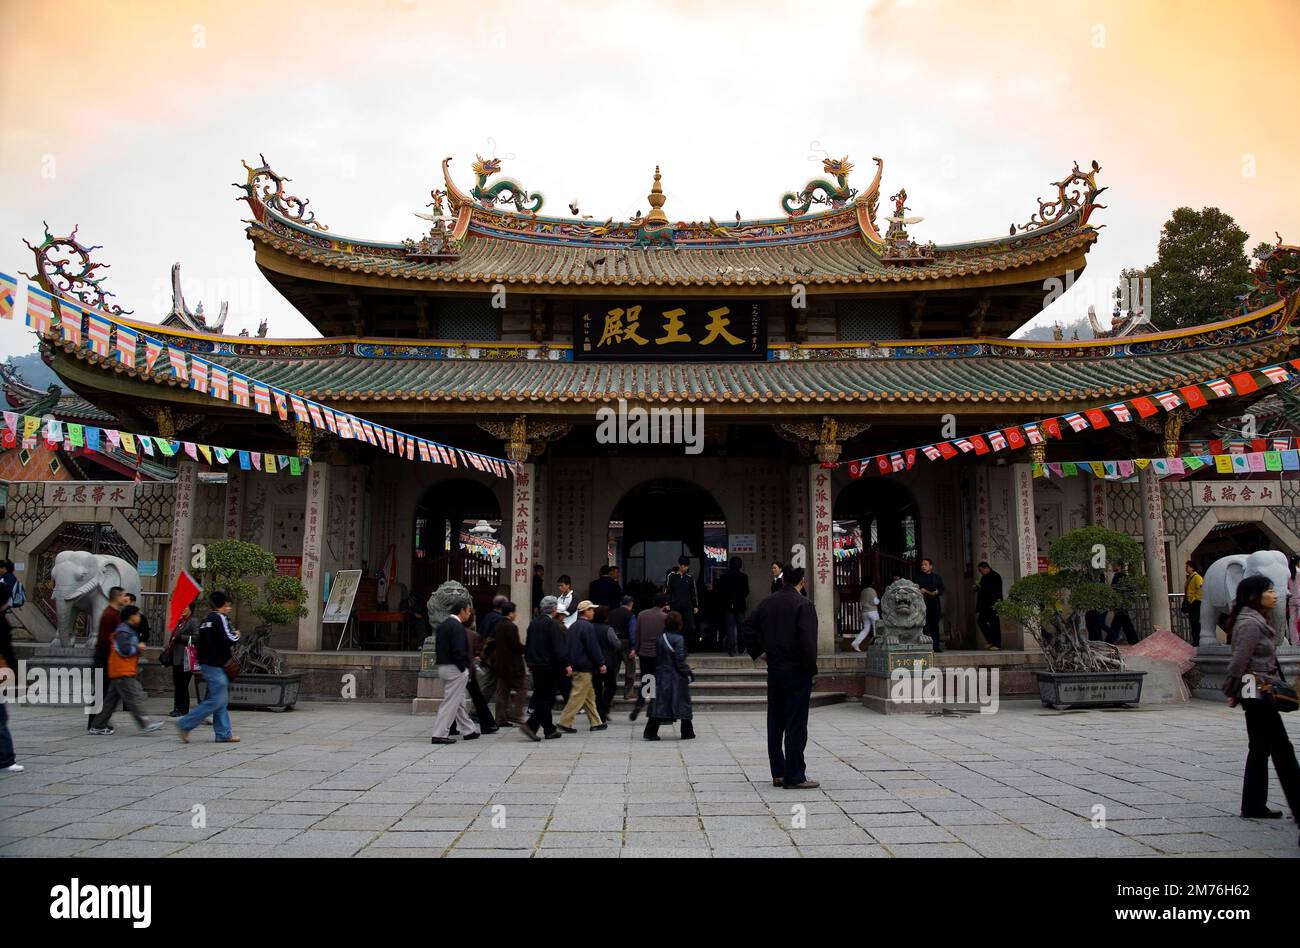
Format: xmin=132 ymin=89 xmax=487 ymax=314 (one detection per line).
xmin=832 ymin=477 xmax=920 ymax=635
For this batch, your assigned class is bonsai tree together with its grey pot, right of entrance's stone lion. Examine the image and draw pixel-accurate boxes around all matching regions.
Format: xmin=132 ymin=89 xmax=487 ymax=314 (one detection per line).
xmin=997 ymin=527 xmax=1147 ymax=710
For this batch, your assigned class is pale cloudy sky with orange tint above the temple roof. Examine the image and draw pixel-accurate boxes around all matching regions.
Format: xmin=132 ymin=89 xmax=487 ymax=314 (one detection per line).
xmin=0 ymin=0 xmax=1300 ymax=356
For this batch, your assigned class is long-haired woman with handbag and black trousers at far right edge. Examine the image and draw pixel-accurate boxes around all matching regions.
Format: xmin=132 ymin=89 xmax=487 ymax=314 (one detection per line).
xmin=1223 ymin=576 xmax=1300 ymax=837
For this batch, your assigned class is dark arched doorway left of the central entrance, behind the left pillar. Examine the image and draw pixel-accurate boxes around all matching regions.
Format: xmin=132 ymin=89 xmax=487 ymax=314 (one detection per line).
xmin=411 ymin=479 xmax=506 ymax=615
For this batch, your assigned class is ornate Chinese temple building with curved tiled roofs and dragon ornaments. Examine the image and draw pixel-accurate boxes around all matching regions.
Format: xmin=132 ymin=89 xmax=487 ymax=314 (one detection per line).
xmin=9 ymin=148 xmax=1300 ymax=697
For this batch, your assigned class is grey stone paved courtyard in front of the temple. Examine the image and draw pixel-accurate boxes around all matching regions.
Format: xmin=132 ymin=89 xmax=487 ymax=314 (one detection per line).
xmin=0 ymin=701 xmax=1300 ymax=857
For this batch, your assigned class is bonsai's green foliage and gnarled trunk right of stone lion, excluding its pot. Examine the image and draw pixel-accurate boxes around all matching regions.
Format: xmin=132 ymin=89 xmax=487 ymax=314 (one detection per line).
xmin=997 ymin=527 xmax=1147 ymax=672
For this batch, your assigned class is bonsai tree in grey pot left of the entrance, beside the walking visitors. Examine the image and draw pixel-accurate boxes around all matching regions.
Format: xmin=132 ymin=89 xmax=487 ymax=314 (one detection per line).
xmin=204 ymin=540 xmax=307 ymax=711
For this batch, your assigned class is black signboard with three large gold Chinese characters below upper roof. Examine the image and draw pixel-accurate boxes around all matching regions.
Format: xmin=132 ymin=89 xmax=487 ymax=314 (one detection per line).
xmin=573 ymin=299 xmax=767 ymax=362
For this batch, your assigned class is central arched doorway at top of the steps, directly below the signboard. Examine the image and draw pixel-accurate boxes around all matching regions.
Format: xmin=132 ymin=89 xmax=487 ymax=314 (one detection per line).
xmin=607 ymin=479 xmax=727 ymax=632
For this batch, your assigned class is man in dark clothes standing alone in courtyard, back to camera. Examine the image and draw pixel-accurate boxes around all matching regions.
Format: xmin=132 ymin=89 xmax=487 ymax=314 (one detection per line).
xmin=744 ymin=568 xmax=820 ymax=789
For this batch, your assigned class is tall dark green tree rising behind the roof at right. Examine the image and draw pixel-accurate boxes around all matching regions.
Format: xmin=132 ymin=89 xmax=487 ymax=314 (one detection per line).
xmin=1145 ymin=207 xmax=1251 ymax=329
